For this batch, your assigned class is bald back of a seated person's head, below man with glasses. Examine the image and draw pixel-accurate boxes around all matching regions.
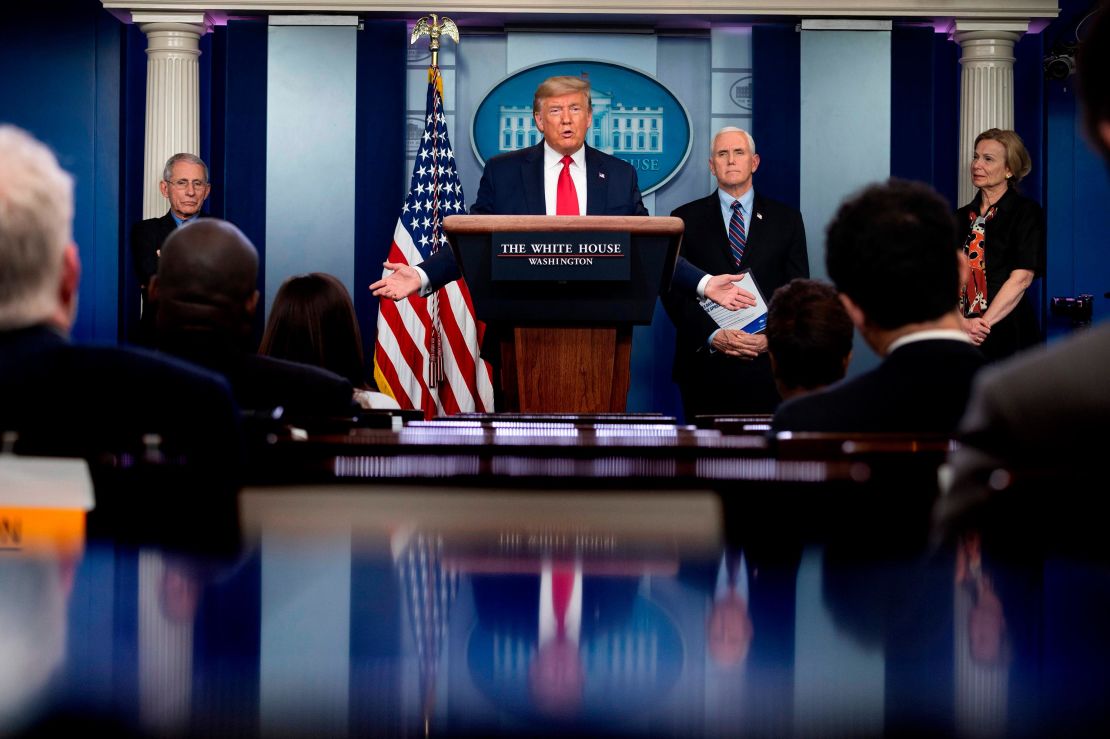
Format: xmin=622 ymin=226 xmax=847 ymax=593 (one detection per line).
xmin=157 ymin=219 xmax=259 ymax=341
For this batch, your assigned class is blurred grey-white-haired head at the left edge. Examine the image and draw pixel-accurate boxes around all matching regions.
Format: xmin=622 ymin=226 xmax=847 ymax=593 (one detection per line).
xmin=0 ymin=125 xmax=73 ymax=330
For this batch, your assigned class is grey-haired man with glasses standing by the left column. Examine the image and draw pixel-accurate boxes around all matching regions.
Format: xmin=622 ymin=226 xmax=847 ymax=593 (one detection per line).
xmin=131 ymin=153 xmax=212 ymax=345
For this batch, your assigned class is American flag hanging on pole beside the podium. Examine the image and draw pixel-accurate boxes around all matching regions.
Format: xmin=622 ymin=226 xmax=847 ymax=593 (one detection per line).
xmin=374 ymin=67 xmax=493 ymax=418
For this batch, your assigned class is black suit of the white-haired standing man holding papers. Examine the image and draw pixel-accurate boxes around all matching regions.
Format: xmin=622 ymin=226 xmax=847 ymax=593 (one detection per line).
xmin=663 ymin=190 xmax=809 ymax=414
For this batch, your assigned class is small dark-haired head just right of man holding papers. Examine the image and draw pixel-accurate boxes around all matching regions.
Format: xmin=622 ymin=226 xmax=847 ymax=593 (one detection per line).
xmin=767 ymin=277 xmax=852 ymax=389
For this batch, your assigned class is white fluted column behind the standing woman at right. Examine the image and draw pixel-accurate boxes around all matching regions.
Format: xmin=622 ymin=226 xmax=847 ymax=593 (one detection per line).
xmin=951 ymin=20 xmax=1029 ymax=206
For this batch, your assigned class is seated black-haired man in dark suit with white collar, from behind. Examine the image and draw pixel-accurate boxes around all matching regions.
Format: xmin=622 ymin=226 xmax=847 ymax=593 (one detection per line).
xmin=771 ymin=180 xmax=983 ymax=433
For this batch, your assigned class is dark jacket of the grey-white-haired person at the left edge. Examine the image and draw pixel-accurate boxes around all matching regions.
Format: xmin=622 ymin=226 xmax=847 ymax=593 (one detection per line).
xmin=0 ymin=325 xmax=240 ymax=473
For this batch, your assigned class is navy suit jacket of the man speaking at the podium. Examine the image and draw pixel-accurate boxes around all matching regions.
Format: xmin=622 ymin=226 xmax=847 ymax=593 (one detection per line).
xmin=420 ymin=142 xmax=704 ymax=294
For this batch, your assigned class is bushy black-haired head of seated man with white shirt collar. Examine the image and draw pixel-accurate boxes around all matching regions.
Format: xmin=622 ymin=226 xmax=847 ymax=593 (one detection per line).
xmin=826 ymin=180 xmax=959 ymax=330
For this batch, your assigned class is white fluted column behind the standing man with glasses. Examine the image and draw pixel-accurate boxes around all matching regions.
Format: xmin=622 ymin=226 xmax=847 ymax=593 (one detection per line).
xmin=131 ymin=12 xmax=211 ymax=219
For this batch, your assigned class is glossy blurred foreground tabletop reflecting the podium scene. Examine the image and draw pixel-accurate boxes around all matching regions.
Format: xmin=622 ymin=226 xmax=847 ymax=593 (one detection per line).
xmin=0 ymin=486 xmax=1110 ymax=737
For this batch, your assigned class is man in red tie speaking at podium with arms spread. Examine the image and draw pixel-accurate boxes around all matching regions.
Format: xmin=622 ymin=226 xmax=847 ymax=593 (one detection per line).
xmin=370 ymin=77 xmax=754 ymax=311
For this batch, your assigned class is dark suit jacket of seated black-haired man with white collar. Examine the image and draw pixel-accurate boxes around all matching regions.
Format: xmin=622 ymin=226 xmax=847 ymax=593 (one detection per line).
xmin=771 ymin=338 xmax=985 ymax=434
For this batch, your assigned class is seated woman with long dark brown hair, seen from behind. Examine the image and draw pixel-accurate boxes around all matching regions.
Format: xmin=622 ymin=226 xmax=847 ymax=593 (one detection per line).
xmin=259 ymin=272 xmax=400 ymax=408
